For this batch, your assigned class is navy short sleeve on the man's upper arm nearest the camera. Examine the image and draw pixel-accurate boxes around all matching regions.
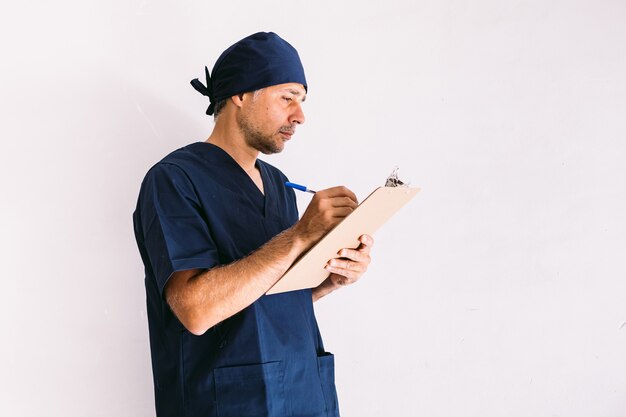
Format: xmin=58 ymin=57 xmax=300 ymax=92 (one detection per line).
xmin=140 ymin=163 xmax=219 ymax=296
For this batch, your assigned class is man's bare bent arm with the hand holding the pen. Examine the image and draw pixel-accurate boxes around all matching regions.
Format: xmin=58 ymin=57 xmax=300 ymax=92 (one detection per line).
xmin=164 ymin=187 xmax=357 ymax=335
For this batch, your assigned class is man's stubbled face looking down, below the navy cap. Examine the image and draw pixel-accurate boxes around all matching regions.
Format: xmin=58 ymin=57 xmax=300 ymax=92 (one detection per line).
xmin=237 ymin=83 xmax=306 ymax=154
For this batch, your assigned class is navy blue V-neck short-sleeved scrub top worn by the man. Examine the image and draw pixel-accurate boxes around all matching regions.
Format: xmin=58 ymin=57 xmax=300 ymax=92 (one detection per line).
xmin=133 ymin=142 xmax=339 ymax=417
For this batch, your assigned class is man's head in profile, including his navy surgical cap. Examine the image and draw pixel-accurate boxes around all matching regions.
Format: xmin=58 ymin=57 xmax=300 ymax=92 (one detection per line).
xmin=191 ymin=32 xmax=307 ymax=154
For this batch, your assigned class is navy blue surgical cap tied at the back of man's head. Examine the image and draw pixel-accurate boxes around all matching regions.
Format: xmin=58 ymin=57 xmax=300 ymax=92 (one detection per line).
xmin=191 ymin=32 xmax=307 ymax=115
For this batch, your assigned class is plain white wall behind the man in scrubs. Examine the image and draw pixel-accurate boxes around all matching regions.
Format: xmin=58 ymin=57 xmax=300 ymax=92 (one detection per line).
xmin=0 ymin=0 xmax=626 ymax=417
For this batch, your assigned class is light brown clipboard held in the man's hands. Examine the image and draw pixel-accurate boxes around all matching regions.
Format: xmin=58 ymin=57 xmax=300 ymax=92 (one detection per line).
xmin=266 ymin=186 xmax=420 ymax=295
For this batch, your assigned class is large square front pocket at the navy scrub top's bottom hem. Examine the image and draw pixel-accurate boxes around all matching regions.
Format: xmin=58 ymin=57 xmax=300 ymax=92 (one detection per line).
xmin=213 ymin=362 xmax=287 ymax=417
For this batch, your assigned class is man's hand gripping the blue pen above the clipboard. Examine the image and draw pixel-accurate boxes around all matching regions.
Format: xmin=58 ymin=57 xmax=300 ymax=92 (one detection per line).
xmin=293 ymin=186 xmax=358 ymax=247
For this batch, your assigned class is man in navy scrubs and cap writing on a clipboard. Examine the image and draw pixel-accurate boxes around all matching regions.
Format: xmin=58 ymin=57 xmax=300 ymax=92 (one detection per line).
xmin=133 ymin=33 xmax=373 ymax=417
